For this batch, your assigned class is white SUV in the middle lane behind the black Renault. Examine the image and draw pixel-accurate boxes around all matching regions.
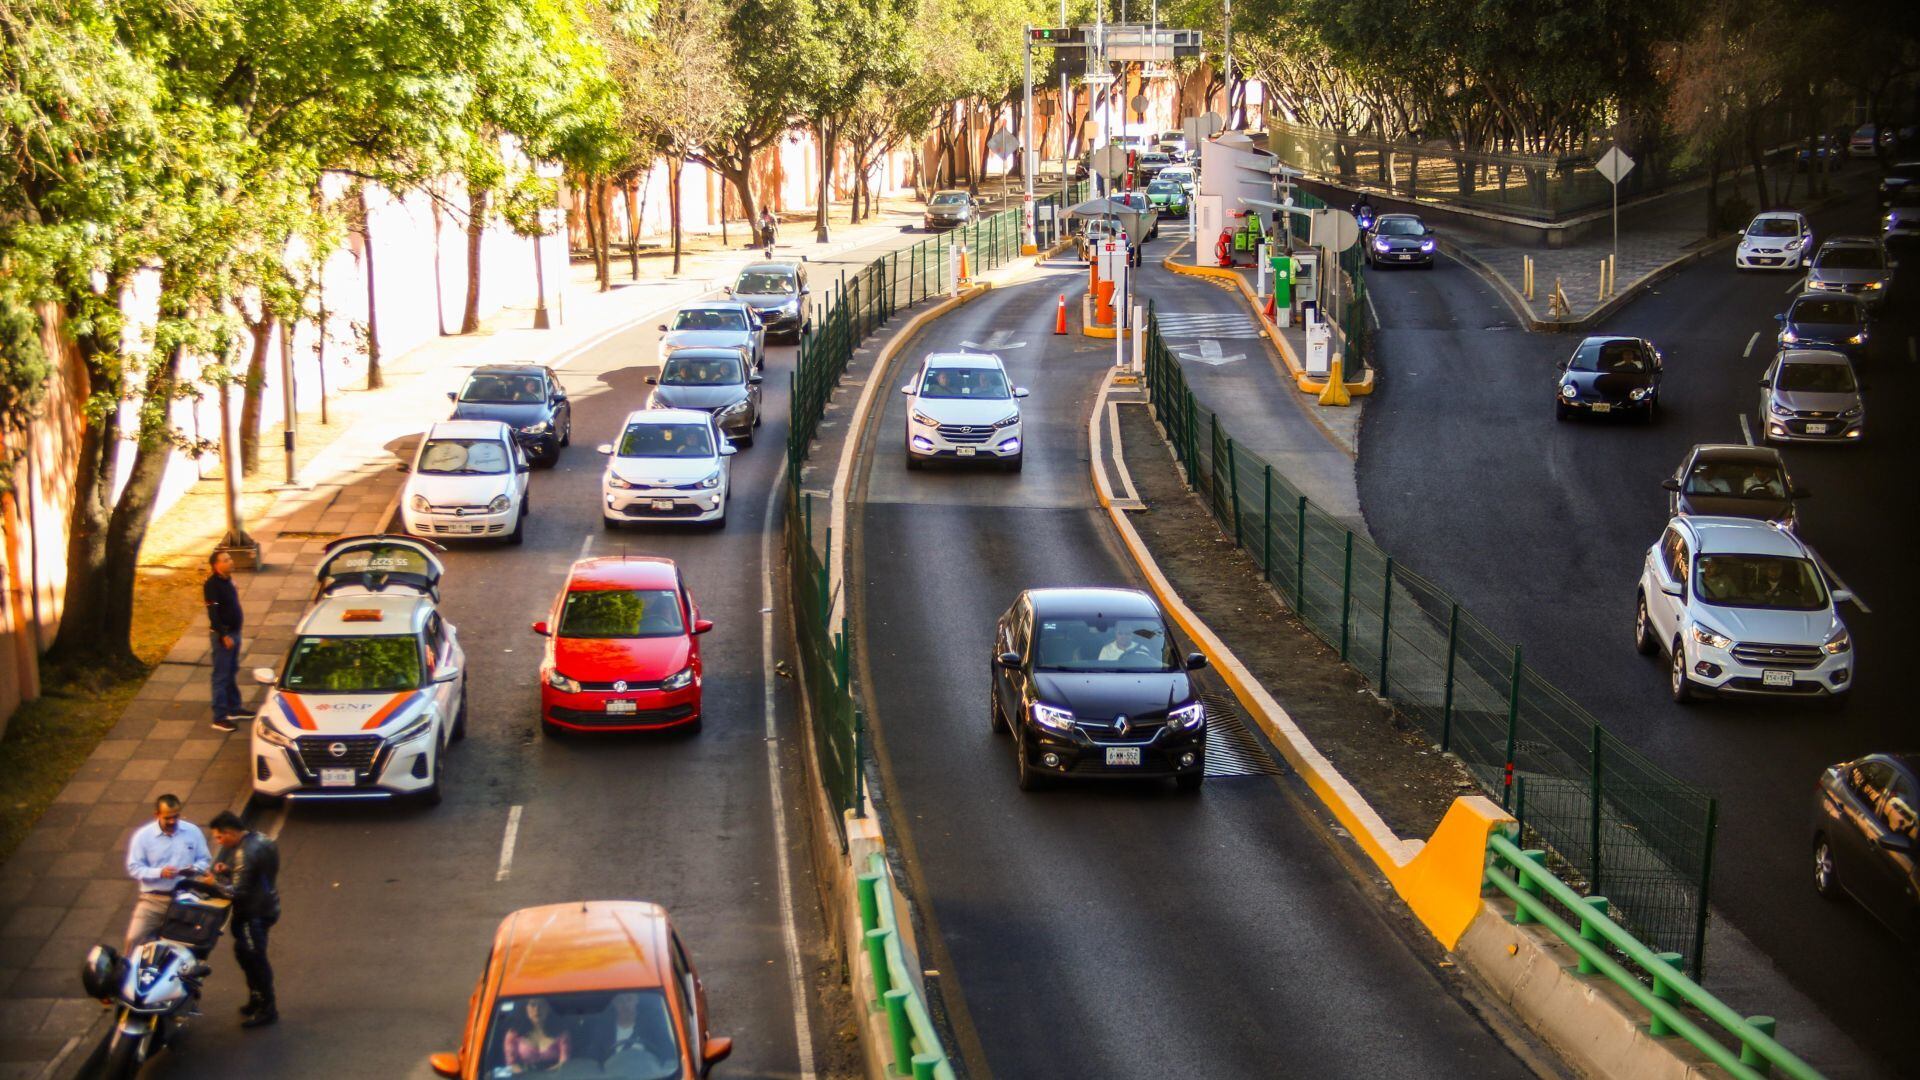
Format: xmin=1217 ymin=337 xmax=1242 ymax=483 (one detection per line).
xmin=900 ymin=352 xmax=1027 ymax=473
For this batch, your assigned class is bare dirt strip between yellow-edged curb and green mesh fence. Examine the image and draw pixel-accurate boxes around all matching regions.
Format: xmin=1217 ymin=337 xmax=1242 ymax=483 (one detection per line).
xmin=1119 ymin=405 xmax=1478 ymax=840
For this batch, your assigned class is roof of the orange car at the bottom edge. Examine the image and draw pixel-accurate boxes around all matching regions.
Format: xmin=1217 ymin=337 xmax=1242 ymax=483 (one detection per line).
xmin=493 ymin=899 xmax=668 ymax=997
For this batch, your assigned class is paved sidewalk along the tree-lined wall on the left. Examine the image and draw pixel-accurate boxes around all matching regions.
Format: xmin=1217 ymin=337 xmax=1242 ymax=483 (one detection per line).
xmin=0 ymin=217 xmax=929 ymax=1080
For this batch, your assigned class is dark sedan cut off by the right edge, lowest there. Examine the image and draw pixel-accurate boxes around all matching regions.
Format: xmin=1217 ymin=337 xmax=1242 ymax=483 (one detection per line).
xmin=1812 ymin=753 xmax=1920 ymax=944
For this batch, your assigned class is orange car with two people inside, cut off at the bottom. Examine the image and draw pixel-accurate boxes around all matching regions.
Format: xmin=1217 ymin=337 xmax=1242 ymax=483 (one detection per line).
xmin=430 ymin=901 xmax=733 ymax=1080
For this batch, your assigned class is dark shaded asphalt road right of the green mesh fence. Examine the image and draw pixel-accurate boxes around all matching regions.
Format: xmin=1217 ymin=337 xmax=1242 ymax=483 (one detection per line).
xmin=1359 ymin=187 xmax=1920 ymax=1068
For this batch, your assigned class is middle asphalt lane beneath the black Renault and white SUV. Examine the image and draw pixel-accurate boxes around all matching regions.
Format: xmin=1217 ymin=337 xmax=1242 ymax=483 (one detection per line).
xmin=851 ymin=261 xmax=1528 ymax=1078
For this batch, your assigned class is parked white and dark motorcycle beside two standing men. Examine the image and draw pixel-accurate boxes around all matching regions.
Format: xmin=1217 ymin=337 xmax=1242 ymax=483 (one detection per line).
xmin=81 ymin=878 xmax=232 ymax=1080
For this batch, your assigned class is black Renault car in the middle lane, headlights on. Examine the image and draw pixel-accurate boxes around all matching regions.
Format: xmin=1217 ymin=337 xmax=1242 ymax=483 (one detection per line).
xmin=991 ymin=588 xmax=1206 ymax=792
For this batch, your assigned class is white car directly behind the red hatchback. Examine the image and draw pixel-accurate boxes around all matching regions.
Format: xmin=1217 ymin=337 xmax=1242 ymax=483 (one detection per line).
xmin=599 ymin=409 xmax=737 ymax=528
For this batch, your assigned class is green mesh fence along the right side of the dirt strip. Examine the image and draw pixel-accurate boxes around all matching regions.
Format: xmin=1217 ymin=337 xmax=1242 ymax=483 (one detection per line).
xmin=1144 ymin=311 xmax=1716 ymax=978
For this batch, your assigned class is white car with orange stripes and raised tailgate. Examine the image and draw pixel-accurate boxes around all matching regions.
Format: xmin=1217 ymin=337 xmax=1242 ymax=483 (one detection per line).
xmin=250 ymin=536 xmax=467 ymax=805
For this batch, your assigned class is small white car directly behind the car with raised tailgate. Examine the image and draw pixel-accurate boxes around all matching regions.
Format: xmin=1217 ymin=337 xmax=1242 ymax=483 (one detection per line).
xmin=399 ymin=421 xmax=530 ymax=544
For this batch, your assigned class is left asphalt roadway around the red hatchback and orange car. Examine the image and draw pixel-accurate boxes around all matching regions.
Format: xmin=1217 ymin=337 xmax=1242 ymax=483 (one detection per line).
xmin=150 ymin=234 xmax=920 ymax=1078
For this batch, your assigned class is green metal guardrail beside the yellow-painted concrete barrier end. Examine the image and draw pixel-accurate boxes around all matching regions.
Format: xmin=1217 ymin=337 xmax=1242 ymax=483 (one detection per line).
xmin=1486 ymin=832 xmax=1820 ymax=1080
